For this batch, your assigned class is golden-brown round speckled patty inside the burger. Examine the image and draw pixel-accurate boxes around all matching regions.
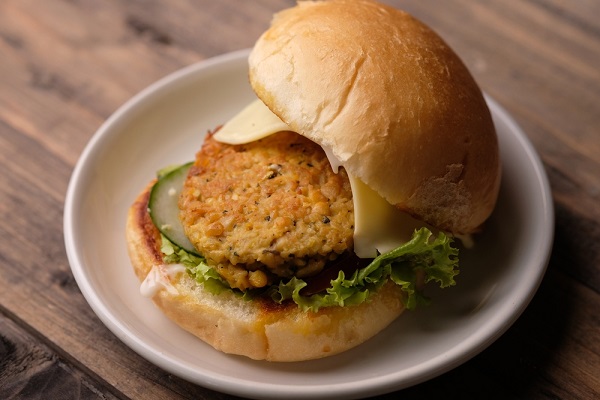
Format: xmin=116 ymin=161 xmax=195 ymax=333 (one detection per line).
xmin=179 ymin=132 xmax=354 ymax=289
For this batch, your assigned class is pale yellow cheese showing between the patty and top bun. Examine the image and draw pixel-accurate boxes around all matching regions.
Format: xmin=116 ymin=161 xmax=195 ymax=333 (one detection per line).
xmin=213 ymin=100 xmax=423 ymax=258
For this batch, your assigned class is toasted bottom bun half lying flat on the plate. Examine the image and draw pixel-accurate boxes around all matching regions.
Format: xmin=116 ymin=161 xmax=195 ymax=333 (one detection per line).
xmin=126 ymin=186 xmax=404 ymax=362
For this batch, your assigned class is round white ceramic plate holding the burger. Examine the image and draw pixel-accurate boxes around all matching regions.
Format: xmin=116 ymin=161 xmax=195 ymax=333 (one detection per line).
xmin=64 ymin=51 xmax=554 ymax=399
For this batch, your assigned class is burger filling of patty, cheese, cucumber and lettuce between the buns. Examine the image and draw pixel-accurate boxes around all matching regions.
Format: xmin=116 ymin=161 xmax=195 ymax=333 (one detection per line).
xmin=148 ymin=103 xmax=459 ymax=312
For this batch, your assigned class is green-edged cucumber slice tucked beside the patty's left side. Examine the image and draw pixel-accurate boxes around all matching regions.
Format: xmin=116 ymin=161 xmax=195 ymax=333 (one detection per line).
xmin=148 ymin=162 xmax=200 ymax=255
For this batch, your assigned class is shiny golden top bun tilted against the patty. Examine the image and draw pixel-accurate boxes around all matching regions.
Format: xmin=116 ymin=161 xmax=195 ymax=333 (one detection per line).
xmin=249 ymin=0 xmax=500 ymax=234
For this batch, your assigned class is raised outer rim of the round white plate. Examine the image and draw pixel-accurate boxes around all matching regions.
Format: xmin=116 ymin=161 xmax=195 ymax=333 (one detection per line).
xmin=63 ymin=49 xmax=554 ymax=398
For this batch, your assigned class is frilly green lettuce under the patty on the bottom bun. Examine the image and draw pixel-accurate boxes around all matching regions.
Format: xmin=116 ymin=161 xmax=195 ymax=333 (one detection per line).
xmin=161 ymin=228 xmax=459 ymax=312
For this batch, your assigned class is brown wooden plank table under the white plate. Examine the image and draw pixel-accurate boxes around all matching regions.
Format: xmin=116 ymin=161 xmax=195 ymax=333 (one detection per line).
xmin=0 ymin=0 xmax=600 ymax=399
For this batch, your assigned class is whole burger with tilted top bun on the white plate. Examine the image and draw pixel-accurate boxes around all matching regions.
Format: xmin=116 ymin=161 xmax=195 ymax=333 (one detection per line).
xmin=126 ymin=0 xmax=500 ymax=361
